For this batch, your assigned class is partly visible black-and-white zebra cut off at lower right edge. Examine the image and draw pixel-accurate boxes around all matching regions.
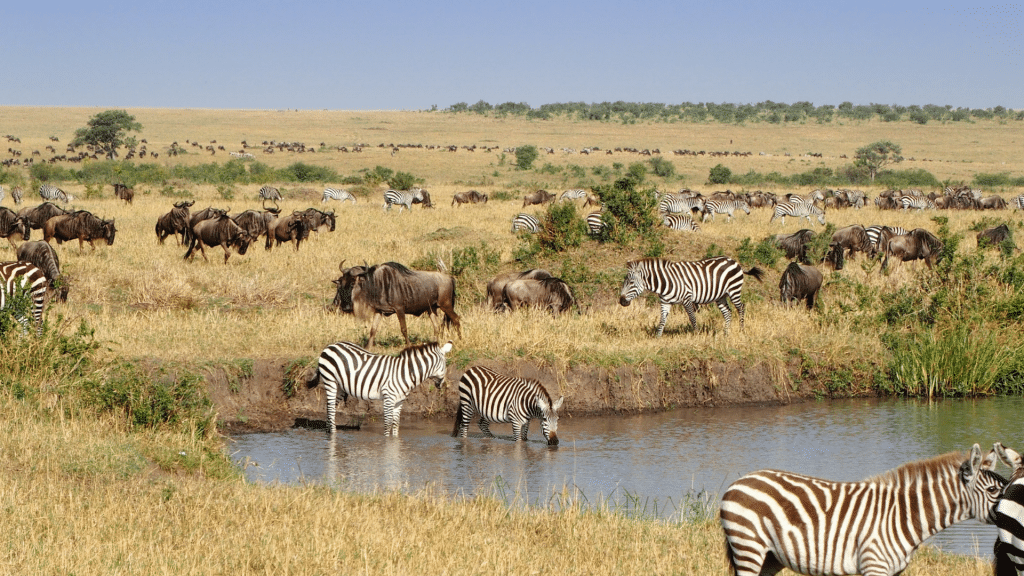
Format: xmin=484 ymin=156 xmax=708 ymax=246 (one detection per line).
xmin=992 ymin=442 xmax=1024 ymax=576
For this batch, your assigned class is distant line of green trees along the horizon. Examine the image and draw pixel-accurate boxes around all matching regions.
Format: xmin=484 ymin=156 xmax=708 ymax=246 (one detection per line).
xmin=445 ymin=100 xmax=1024 ymax=124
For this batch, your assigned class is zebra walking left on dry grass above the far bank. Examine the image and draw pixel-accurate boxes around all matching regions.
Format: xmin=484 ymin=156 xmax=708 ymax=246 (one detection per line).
xmin=618 ymin=256 xmax=764 ymax=337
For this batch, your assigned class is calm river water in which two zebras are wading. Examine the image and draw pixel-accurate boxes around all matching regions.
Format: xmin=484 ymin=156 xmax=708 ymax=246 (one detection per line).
xmin=229 ymin=398 xmax=1024 ymax=557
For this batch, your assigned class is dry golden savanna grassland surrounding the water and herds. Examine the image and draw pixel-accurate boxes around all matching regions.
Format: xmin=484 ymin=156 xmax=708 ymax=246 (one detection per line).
xmin=0 ymin=108 xmax=1024 ymax=574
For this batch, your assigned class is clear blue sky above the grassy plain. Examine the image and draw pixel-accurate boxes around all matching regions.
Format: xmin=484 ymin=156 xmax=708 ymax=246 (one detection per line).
xmin=0 ymin=0 xmax=1024 ymax=110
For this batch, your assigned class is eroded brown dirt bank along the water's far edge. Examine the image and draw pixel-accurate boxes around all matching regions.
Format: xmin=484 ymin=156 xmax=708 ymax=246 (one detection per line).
xmin=205 ymin=359 xmax=821 ymax=433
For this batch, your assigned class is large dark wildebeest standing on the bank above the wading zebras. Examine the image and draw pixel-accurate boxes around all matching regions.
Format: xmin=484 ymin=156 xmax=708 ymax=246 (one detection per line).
xmin=333 ymin=260 xmax=462 ymax=346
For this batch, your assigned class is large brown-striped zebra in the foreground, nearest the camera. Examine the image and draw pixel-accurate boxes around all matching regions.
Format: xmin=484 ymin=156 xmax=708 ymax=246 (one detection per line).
xmin=720 ymin=444 xmax=1007 ymax=576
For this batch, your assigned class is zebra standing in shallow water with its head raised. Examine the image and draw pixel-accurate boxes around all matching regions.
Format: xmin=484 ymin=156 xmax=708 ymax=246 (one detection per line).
xmin=308 ymin=341 xmax=452 ymax=436
